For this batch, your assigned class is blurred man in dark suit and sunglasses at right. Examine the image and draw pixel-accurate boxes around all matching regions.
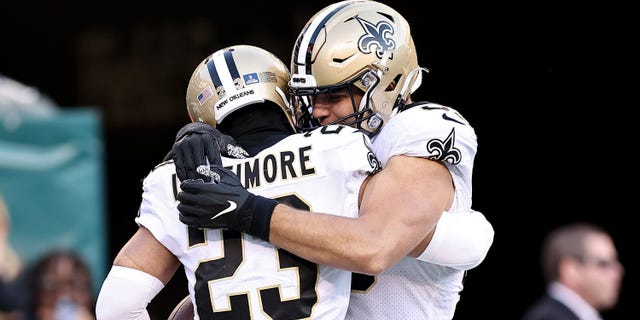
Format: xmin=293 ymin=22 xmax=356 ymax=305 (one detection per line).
xmin=522 ymin=222 xmax=624 ymax=320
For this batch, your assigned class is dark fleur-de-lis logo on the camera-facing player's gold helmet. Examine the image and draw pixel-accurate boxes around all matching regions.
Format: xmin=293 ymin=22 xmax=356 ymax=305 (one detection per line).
xmin=355 ymin=16 xmax=396 ymax=59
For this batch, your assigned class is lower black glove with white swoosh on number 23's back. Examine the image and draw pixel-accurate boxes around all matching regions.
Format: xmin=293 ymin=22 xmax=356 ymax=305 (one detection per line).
xmin=178 ymin=165 xmax=278 ymax=241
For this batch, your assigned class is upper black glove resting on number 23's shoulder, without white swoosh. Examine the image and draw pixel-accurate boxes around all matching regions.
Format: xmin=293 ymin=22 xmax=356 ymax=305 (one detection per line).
xmin=164 ymin=121 xmax=249 ymax=181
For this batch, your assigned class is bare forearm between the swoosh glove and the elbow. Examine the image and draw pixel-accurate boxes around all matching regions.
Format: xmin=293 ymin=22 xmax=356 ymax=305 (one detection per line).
xmin=270 ymin=204 xmax=390 ymax=274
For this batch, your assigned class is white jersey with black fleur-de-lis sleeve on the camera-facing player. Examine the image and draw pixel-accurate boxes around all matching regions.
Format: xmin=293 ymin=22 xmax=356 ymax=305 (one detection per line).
xmin=347 ymin=103 xmax=477 ymax=320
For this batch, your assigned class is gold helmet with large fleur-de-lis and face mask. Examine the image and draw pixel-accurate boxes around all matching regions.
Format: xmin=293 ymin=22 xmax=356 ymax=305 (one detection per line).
xmin=289 ymin=0 xmax=426 ymax=135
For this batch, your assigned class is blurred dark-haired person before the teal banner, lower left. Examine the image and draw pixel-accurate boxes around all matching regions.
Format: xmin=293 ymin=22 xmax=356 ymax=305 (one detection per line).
xmin=27 ymin=249 xmax=95 ymax=320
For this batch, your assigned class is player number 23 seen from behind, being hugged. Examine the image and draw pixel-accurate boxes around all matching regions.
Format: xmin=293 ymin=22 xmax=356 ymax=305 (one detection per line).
xmin=96 ymin=45 xmax=379 ymax=320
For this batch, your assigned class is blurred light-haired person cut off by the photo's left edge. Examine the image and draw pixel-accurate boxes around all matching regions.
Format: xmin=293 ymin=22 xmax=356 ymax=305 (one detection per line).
xmin=0 ymin=195 xmax=26 ymax=320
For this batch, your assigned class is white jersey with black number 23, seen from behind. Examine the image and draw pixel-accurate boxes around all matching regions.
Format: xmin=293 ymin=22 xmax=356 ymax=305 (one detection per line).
xmin=136 ymin=126 xmax=380 ymax=320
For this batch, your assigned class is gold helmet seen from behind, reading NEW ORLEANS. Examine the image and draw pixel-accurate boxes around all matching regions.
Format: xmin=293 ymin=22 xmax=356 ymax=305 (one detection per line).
xmin=187 ymin=45 xmax=296 ymax=130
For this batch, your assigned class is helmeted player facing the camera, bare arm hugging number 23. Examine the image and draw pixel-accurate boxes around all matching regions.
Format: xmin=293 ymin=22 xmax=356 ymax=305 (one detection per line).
xmin=178 ymin=0 xmax=494 ymax=319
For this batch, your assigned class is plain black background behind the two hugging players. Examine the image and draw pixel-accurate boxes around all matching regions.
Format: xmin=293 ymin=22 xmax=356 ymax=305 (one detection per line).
xmin=0 ymin=1 xmax=639 ymax=319
